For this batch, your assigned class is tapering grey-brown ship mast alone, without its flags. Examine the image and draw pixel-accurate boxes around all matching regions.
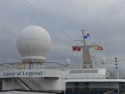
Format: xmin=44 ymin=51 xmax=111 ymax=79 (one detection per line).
xmin=81 ymin=30 xmax=93 ymax=69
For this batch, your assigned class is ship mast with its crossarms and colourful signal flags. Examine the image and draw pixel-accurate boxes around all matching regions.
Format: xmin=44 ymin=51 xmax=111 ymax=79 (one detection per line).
xmin=72 ymin=29 xmax=103 ymax=69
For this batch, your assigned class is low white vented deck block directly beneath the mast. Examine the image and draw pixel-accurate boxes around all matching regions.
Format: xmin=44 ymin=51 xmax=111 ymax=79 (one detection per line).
xmin=68 ymin=69 xmax=107 ymax=79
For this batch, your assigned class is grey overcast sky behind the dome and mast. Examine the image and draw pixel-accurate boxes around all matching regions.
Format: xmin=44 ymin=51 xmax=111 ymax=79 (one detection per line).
xmin=0 ymin=0 xmax=125 ymax=67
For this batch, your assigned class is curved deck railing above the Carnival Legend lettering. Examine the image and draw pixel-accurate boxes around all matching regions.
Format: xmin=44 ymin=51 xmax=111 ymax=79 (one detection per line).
xmin=0 ymin=62 xmax=67 ymax=71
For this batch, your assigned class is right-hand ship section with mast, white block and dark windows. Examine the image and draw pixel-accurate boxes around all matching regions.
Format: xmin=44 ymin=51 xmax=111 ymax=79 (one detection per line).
xmin=66 ymin=30 xmax=125 ymax=94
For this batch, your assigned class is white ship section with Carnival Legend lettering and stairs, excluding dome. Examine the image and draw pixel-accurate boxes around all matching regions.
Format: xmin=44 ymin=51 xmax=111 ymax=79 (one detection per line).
xmin=0 ymin=62 xmax=68 ymax=93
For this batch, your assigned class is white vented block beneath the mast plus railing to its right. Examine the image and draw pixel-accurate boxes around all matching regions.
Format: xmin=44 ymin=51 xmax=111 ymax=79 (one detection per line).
xmin=69 ymin=69 xmax=125 ymax=79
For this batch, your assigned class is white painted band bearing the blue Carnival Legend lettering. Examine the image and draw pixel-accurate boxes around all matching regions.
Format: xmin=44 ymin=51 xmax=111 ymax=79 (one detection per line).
xmin=0 ymin=69 xmax=68 ymax=78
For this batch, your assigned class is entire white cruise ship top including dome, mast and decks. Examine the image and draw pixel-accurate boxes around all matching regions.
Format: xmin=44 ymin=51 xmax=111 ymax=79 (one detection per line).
xmin=0 ymin=26 xmax=125 ymax=94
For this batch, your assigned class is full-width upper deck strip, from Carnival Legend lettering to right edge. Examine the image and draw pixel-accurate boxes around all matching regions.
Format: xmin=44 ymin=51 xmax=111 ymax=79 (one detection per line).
xmin=0 ymin=62 xmax=125 ymax=79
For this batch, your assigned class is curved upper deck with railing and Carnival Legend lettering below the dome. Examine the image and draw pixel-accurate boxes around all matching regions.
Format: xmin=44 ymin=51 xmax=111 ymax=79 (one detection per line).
xmin=0 ymin=62 xmax=68 ymax=78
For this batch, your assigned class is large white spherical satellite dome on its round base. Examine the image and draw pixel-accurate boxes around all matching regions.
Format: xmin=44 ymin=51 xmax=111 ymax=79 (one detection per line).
xmin=16 ymin=26 xmax=51 ymax=62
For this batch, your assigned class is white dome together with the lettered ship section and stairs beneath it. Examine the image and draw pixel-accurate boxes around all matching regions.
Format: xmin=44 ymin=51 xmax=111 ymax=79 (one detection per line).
xmin=0 ymin=26 xmax=68 ymax=94
